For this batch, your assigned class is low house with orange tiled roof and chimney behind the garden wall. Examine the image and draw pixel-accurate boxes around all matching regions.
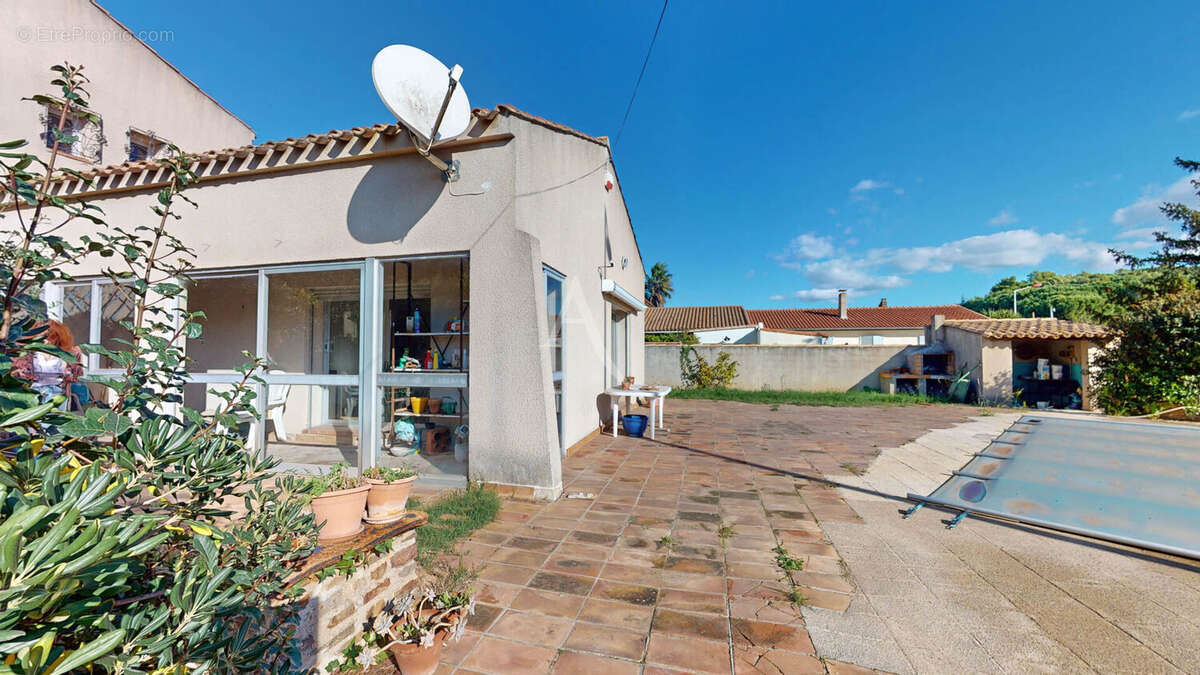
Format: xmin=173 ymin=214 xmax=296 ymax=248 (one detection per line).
xmin=746 ymin=291 xmax=986 ymax=345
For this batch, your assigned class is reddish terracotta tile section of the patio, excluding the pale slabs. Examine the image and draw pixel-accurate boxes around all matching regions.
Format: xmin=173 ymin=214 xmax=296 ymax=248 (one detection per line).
xmin=439 ymin=401 xmax=977 ymax=675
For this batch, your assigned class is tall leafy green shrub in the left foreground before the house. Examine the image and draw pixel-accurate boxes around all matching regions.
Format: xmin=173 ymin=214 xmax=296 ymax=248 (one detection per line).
xmin=0 ymin=65 xmax=317 ymax=675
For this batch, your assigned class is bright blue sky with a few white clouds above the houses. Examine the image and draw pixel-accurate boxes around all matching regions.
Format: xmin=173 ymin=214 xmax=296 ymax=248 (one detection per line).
xmin=104 ymin=0 xmax=1200 ymax=307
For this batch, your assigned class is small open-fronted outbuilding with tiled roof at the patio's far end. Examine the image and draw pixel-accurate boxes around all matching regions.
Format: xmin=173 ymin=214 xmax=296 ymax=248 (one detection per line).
xmin=929 ymin=316 xmax=1110 ymax=410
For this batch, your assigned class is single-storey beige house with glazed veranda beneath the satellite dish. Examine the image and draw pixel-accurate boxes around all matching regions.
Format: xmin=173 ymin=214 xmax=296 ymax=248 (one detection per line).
xmin=11 ymin=15 xmax=644 ymax=498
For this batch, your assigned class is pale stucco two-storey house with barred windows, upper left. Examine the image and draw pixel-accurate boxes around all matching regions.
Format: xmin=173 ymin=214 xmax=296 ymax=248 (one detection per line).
xmin=0 ymin=0 xmax=254 ymax=169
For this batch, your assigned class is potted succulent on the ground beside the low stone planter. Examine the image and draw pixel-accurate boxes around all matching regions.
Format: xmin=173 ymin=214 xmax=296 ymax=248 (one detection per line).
xmin=328 ymin=558 xmax=479 ymax=675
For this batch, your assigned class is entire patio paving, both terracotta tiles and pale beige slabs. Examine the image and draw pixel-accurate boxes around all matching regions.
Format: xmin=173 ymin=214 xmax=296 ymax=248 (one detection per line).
xmin=424 ymin=401 xmax=1200 ymax=675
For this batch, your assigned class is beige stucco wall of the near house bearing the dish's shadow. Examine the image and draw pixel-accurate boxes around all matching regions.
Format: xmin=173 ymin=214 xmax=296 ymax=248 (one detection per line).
xmin=45 ymin=112 xmax=644 ymax=496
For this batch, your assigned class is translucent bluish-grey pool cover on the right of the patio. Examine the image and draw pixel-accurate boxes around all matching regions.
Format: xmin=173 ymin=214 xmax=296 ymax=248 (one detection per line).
xmin=906 ymin=416 xmax=1200 ymax=558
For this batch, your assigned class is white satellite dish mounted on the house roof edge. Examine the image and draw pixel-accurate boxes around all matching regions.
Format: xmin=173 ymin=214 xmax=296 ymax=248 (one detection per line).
xmin=371 ymin=44 xmax=470 ymax=177
